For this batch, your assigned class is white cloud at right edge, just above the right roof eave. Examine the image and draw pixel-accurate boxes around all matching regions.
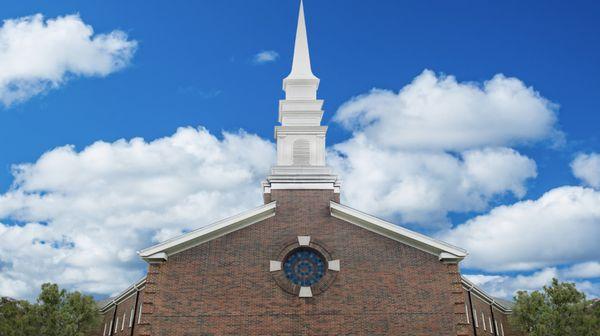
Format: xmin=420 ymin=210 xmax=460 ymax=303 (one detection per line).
xmin=440 ymin=186 xmax=600 ymax=273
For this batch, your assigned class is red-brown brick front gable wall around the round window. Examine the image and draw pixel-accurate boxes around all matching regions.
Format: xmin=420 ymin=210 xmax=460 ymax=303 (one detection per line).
xmin=139 ymin=190 xmax=468 ymax=336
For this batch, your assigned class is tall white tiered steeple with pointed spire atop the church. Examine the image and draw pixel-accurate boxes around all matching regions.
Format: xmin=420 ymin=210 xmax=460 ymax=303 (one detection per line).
xmin=263 ymin=1 xmax=340 ymax=194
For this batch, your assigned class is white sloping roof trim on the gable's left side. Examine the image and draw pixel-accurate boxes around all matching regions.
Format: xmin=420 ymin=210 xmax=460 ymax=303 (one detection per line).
xmin=138 ymin=202 xmax=276 ymax=262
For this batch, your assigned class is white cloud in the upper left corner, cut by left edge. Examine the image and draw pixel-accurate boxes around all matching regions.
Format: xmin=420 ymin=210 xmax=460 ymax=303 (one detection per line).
xmin=0 ymin=14 xmax=137 ymax=106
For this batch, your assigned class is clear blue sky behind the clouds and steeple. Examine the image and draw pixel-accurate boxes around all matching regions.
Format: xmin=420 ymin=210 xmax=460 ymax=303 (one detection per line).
xmin=0 ymin=0 xmax=600 ymax=297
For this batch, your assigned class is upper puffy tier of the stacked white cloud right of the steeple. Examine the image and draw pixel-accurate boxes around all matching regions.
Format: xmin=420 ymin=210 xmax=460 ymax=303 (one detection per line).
xmin=334 ymin=70 xmax=561 ymax=151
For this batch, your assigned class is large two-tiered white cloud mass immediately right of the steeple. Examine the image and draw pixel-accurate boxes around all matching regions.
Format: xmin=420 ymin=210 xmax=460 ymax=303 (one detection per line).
xmin=330 ymin=70 xmax=561 ymax=227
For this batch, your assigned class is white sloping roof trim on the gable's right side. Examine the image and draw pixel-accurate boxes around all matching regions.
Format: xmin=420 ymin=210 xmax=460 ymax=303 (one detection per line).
xmin=329 ymin=201 xmax=467 ymax=262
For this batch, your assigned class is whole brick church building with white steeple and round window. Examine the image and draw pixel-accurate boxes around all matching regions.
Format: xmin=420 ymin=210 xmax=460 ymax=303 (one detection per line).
xmin=97 ymin=4 xmax=515 ymax=336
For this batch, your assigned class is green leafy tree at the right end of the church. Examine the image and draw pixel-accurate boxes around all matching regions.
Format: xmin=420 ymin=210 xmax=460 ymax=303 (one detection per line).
xmin=510 ymin=279 xmax=600 ymax=336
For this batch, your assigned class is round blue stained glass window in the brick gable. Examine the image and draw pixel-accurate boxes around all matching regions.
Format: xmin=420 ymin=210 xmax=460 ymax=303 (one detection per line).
xmin=283 ymin=248 xmax=326 ymax=287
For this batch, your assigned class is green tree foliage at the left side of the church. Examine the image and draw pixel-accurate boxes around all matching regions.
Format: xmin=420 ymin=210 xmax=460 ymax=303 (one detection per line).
xmin=0 ymin=284 xmax=100 ymax=336
